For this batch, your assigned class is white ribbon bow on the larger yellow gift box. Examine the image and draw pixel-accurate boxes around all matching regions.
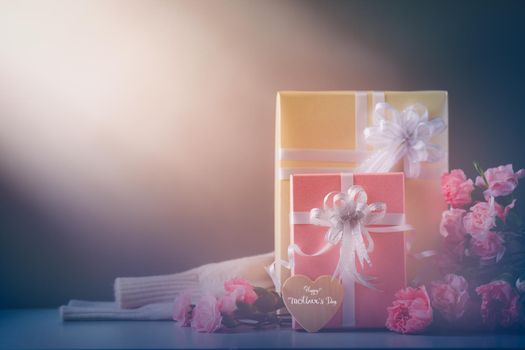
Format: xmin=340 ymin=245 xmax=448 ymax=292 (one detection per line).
xmin=356 ymin=102 xmax=446 ymax=178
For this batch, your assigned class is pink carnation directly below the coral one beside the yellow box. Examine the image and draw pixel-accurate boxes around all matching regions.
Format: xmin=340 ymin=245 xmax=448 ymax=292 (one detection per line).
xmin=439 ymin=208 xmax=466 ymax=257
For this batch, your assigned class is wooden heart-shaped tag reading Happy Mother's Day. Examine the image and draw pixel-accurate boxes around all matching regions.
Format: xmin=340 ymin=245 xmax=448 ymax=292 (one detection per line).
xmin=281 ymin=275 xmax=344 ymax=332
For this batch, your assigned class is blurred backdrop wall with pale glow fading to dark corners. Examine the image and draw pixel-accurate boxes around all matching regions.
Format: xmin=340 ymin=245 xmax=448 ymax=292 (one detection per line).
xmin=0 ymin=1 xmax=525 ymax=307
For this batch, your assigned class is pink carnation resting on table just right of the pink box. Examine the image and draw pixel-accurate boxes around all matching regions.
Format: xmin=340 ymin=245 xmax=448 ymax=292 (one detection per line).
xmin=386 ymin=286 xmax=432 ymax=334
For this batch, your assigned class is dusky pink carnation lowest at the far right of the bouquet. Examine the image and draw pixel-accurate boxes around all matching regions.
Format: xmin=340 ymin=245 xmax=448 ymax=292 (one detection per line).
xmin=476 ymin=280 xmax=519 ymax=327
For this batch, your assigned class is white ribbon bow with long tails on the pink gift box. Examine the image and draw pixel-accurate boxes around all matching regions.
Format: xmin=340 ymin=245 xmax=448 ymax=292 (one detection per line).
xmin=310 ymin=186 xmax=386 ymax=288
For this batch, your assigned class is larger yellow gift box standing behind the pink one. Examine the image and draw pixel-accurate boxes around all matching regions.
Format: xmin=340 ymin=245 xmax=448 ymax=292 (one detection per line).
xmin=275 ymin=91 xmax=448 ymax=288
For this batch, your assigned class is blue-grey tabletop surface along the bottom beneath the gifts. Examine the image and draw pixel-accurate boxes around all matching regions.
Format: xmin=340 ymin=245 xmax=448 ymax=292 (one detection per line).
xmin=0 ymin=309 xmax=525 ymax=349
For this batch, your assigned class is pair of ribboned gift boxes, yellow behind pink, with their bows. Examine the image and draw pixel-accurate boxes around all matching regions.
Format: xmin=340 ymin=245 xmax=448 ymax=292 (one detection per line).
xmin=275 ymin=91 xmax=448 ymax=328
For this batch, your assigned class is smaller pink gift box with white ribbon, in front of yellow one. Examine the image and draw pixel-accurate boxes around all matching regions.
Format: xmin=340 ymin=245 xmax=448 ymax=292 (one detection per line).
xmin=290 ymin=173 xmax=406 ymax=329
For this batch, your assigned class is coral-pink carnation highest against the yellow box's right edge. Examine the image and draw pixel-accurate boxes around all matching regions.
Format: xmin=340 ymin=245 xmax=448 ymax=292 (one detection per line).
xmin=441 ymin=169 xmax=474 ymax=208
